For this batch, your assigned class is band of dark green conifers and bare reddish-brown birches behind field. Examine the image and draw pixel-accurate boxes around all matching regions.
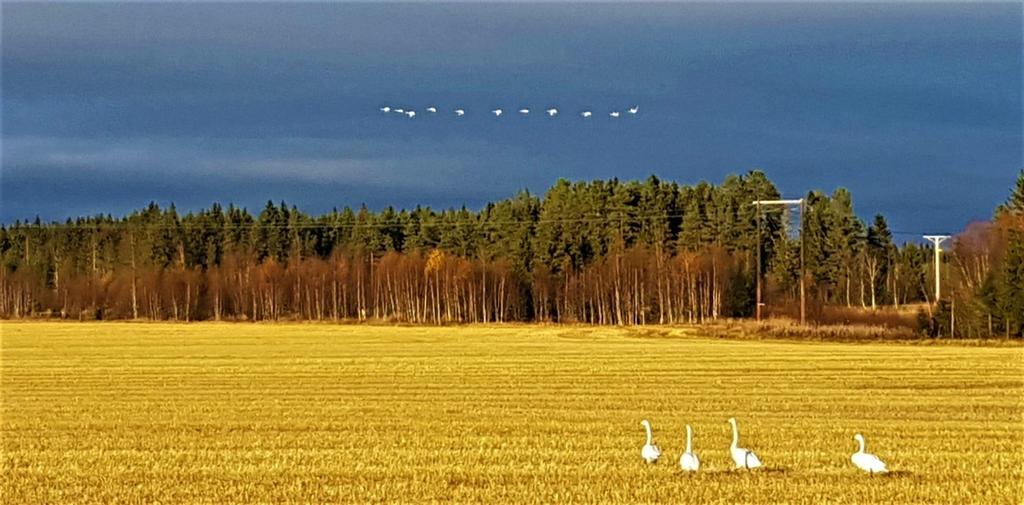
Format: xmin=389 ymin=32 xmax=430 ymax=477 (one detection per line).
xmin=0 ymin=171 xmax=1024 ymax=338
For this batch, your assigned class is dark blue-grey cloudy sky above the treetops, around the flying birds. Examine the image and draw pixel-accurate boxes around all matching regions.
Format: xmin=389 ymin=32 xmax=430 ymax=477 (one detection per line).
xmin=0 ymin=2 xmax=1024 ymax=235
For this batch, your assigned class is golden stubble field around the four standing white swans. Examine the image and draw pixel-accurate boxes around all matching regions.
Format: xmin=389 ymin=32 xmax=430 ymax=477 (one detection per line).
xmin=0 ymin=322 xmax=1024 ymax=504
